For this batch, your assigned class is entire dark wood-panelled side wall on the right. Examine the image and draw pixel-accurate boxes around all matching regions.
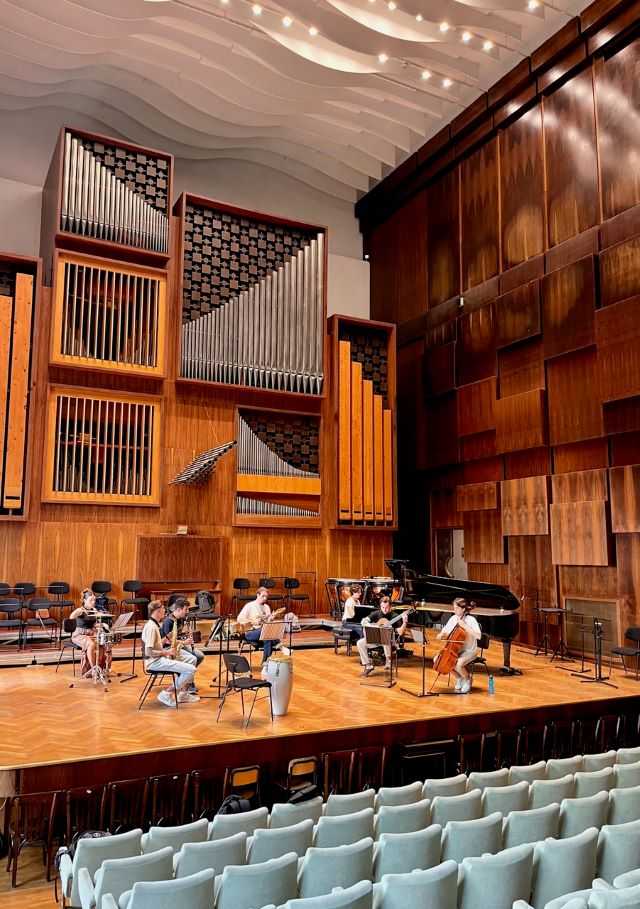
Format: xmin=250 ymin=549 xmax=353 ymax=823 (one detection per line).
xmin=358 ymin=7 xmax=640 ymax=637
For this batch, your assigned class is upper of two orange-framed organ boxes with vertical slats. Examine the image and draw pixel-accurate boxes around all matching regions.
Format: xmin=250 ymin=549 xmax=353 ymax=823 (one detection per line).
xmin=51 ymin=252 xmax=167 ymax=376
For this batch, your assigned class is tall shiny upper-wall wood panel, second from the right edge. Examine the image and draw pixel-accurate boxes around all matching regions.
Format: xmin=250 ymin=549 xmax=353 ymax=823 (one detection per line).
xmin=543 ymin=69 xmax=599 ymax=246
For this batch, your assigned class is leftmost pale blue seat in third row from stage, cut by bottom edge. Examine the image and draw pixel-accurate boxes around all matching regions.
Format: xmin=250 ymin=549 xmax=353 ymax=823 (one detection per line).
xmin=102 ymin=868 xmax=215 ymax=909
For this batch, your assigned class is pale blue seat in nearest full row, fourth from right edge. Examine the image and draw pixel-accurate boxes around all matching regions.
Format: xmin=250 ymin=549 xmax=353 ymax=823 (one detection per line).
xmin=373 ymin=862 xmax=458 ymax=909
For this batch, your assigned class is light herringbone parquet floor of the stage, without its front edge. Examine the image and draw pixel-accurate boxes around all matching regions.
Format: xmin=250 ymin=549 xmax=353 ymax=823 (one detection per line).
xmin=0 ymin=644 xmax=640 ymax=770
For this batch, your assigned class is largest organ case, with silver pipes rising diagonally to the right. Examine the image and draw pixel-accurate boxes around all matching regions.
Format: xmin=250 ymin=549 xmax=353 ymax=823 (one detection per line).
xmin=178 ymin=196 xmax=326 ymax=396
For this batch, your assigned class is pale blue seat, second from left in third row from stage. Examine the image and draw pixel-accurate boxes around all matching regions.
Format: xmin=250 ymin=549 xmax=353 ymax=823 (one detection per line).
xmin=215 ymin=852 xmax=298 ymax=909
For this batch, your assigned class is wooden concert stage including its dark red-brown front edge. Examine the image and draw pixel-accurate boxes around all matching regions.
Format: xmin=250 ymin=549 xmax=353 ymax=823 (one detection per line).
xmin=0 ymin=644 xmax=640 ymax=792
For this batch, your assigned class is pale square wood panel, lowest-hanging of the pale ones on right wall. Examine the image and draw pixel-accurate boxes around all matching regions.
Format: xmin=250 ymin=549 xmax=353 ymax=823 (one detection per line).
xmin=551 ymin=501 xmax=609 ymax=565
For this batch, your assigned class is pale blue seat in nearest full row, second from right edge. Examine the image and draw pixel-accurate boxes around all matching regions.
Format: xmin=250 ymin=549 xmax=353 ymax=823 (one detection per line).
xmin=531 ymin=827 xmax=598 ymax=909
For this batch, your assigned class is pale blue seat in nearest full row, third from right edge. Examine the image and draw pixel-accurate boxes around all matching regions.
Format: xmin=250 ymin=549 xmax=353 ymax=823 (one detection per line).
xmin=458 ymin=846 xmax=533 ymax=909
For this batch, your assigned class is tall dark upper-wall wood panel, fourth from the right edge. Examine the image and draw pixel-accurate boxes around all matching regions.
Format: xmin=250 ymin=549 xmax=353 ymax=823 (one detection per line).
xmin=460 ymin=139 xmax=500 ymax=290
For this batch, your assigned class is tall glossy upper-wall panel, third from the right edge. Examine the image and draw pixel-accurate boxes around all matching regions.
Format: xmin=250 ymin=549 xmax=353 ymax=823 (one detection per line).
xmin=500 ymin=104 xmax=545 ymax=270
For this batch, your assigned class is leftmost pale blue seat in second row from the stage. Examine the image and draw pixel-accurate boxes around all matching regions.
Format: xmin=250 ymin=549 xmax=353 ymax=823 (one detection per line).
xmin=78 ymin=846 xmax=173 ymax=909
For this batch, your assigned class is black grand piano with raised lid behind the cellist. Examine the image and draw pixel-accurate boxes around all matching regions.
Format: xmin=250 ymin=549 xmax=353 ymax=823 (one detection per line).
xmin=356 ymin=559 xmax=520 ymax=675
